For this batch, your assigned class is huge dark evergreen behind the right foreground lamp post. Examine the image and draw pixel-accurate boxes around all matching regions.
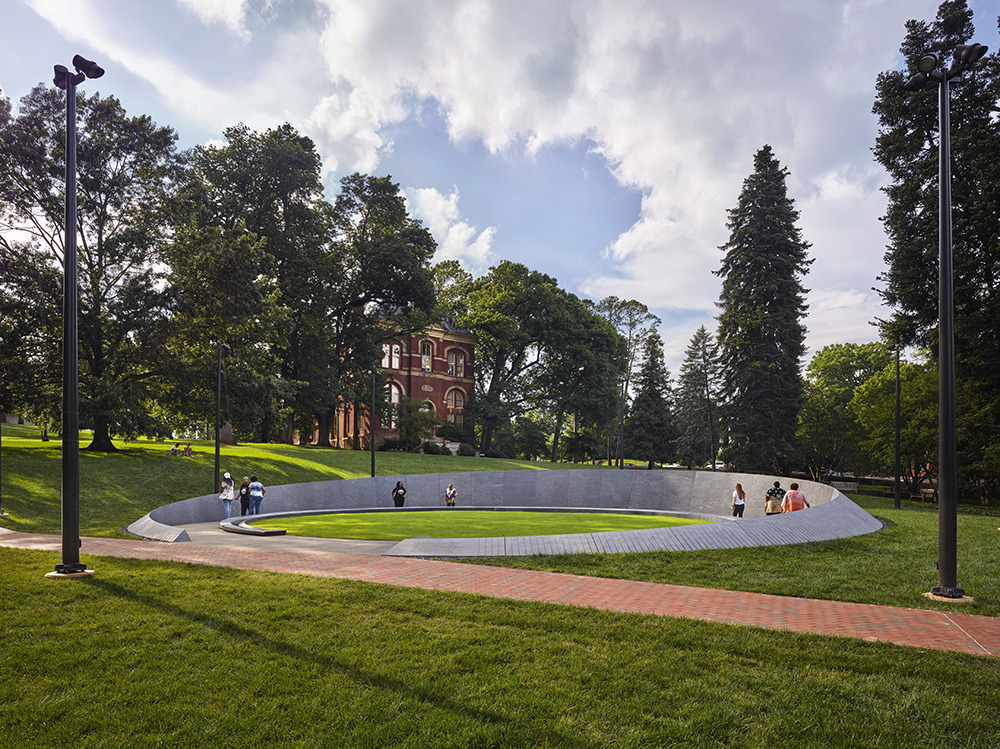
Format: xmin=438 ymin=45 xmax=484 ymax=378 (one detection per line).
xmin=873 ymin=0 xmax=1000 ymax=500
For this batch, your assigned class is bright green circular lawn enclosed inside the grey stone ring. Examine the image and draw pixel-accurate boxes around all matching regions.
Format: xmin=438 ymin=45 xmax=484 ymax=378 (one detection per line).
xmin=260 ymin=509 xmax=706 ymax=541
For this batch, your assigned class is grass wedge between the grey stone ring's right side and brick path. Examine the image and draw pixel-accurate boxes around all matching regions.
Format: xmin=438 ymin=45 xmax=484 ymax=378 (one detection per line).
xmin=468 ymin=495 xmax=1000 ymax=616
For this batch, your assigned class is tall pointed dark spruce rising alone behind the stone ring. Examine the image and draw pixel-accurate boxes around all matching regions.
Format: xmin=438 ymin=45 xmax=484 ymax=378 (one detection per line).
xmin=715 ymin=145 xmax=812 ymax=472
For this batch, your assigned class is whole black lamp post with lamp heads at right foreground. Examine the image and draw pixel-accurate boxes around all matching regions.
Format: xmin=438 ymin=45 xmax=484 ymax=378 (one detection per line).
xmin=904 ymin=44 xmax=988 ymax=598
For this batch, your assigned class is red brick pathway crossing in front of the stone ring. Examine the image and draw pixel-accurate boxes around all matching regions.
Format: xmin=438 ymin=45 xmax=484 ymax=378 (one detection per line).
xmin=0 ymin=529 xmax=1000 ymax=655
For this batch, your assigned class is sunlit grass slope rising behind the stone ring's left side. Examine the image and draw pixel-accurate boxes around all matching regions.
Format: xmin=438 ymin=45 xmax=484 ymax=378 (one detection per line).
xmin=0 ymin=424 xmax=584 ymax=536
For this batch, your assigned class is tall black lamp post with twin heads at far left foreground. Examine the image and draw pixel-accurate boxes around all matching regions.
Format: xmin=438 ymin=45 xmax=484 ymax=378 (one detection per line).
xmin=52 ymin=55 xmax=104 ymax=574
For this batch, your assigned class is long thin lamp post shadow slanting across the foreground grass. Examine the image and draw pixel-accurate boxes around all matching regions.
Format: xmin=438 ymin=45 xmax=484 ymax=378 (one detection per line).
xmin=79 ymin=577 xmax=600 ymax=749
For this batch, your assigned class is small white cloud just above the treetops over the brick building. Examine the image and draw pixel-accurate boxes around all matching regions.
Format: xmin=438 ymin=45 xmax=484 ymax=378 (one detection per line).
xmin=404 ymin=188 xmax=496 ymax=275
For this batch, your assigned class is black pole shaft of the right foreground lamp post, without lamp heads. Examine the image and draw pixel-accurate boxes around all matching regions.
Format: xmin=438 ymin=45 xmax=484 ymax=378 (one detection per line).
xmin=931 ymin=72 xmax=965 ymax=598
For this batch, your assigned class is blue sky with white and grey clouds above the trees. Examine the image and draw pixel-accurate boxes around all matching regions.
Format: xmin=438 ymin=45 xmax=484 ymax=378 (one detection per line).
xmin=0 ymin=0 xmax=1000 ymax=374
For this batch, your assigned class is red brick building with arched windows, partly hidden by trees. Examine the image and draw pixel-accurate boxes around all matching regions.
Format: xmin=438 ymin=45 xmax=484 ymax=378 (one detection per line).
xmin=335 ymin=324 xmax=476 ymax=448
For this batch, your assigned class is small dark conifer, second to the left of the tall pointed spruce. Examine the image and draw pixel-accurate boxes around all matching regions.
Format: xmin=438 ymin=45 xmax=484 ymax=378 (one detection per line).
xmin=625 ymin=333 xmax=676 ymax=469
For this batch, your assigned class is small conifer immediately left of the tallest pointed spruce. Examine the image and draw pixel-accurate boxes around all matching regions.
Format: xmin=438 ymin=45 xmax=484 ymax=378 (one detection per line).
xmin=676 ymin=325 xmax=722 ymax=467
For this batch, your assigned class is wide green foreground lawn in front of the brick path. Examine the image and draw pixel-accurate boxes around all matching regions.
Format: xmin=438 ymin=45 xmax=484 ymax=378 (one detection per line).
xmin=0 ymin=549 xmax=1000 ymax=749
